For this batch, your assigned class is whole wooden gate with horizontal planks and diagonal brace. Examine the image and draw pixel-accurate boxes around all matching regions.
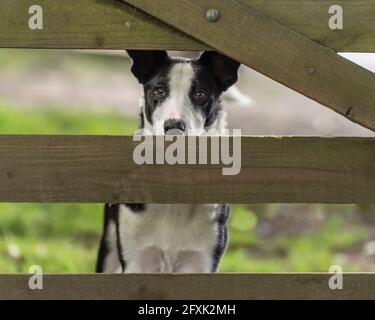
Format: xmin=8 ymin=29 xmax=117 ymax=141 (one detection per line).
xmin=0 ymin=0 xmax=375 ymax=299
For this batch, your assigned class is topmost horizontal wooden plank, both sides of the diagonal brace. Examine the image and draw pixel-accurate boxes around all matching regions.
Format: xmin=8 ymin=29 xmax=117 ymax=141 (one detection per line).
xmin=0 ymin=0 xmax=375 ymax=52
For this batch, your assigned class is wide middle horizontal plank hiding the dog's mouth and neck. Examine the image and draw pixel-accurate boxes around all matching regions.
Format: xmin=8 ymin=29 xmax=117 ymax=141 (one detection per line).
xmin=0 ymin=135 xmax=375 ymax=203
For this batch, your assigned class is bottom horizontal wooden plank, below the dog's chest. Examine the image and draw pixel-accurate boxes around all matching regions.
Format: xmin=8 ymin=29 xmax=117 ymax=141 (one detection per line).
xmin=0 ymin=273 xmax=375 ymax=300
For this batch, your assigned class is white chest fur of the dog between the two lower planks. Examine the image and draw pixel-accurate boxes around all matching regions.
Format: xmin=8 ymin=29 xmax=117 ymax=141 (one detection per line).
xmin=119 ymin=204 xmax=217 ymax=273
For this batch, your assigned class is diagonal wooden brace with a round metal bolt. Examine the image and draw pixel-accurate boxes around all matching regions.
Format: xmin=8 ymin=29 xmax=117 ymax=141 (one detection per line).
xmin=122 ymin=0 xmax=375 ymax=130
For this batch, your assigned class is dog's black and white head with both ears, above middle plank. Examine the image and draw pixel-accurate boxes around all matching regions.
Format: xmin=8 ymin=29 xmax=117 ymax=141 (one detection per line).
xmin=128 ymin=50 xmax=240 ymax=134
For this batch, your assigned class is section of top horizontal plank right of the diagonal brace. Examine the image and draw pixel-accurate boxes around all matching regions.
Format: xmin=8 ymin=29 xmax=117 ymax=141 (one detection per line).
xmin=238 ymin=0 xmax=375 ymax=52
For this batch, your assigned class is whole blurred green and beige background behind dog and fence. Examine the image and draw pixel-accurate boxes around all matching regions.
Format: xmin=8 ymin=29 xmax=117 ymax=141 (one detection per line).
xmin=0 ymin=49 xmax=375 ymax=273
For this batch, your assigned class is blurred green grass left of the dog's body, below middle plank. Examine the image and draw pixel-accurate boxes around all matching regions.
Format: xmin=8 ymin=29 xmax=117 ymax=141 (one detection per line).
xmin=0 ymin=203 xmax=102 ymax=273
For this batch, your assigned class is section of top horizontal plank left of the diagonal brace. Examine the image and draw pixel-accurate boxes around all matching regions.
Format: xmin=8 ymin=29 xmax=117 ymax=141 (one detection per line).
xmin=0 ymin=0 xmax=206 ymax=50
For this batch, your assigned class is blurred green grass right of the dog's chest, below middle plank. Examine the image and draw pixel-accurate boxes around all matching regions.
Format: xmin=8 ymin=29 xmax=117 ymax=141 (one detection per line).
xmin=222 ymin=205 xmax=373 ymax=272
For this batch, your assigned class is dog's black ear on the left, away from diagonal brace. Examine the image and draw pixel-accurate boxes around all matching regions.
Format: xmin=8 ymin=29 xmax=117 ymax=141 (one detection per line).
xmin=127 ymin=50 xmax=169 ymax=84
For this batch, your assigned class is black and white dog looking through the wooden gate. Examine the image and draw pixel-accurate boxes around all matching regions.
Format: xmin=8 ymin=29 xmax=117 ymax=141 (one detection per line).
xmin=97 ymin=51 xmax=240 ymax=273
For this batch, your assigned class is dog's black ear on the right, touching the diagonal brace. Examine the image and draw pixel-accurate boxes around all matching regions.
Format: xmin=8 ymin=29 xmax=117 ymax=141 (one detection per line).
xmin=198 ymin=51 xmax=241 ymax=91
